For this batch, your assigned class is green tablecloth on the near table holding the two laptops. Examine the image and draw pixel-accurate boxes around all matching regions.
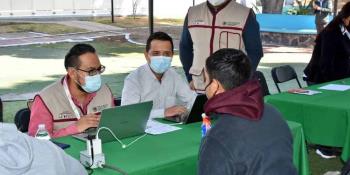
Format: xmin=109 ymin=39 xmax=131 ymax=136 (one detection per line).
xmin=56 ymin=122 xmax=308 ymax=175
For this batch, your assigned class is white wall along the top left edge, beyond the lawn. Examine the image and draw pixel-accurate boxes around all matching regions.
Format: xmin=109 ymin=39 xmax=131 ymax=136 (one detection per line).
xmin=0 ymin=0 xmax=206 ymax=18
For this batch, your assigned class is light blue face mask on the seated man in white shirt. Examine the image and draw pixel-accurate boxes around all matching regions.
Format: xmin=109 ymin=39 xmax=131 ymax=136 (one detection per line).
xmin=149 ymin=56 xmax=171 ymax=74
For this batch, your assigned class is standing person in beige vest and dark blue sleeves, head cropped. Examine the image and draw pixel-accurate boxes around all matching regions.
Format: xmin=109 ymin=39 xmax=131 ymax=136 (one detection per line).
xmin=180 ymin=0 xmax=263 ymax=92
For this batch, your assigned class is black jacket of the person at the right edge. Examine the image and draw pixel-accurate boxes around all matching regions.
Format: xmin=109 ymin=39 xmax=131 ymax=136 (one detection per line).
xmin=304 ymin=27 xmax=350 ymax=83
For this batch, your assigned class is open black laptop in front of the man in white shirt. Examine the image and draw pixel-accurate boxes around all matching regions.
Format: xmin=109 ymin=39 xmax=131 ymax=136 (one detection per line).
xmin=164 ymin=94 xmax=208 ymax=124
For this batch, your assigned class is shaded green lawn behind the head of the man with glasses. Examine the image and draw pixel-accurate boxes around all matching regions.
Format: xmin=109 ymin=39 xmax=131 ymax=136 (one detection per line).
xmin=0 ymin=36 xmax=144 ymax=96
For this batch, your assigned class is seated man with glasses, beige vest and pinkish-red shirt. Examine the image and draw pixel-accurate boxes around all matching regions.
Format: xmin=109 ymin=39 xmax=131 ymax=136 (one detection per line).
xmin=29 ymin=44 xmax=114 ymax=138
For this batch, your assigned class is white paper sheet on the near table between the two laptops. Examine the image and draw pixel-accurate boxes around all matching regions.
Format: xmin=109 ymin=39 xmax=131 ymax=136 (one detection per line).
xmin=145 ymin=119 xmax=181 ymax=135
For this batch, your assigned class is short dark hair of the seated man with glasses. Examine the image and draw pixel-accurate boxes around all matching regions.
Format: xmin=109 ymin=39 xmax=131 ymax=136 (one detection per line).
xmin=64 ymin=43 xmax=96 ymax=69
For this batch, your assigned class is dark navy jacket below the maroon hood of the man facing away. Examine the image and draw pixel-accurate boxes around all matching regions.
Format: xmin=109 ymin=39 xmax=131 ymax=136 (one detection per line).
xmin=198 ymin=104 xmax=297 ymax=175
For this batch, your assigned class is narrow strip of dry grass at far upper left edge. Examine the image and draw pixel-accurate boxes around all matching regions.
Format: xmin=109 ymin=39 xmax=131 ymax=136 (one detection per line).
xmin=0 ymin=22 xmax=86 ymax=34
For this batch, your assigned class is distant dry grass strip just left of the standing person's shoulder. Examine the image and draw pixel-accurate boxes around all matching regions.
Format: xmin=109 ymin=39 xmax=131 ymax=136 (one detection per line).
xmin=92 ymin=16 xmax=184 ymax=28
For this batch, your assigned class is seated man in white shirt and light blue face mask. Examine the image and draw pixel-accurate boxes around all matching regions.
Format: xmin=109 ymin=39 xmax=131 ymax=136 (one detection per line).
xmin=121 ymin=32 xmax=196 ymax=117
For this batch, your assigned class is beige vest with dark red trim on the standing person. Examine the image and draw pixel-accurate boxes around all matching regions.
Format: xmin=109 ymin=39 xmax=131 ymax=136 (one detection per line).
xmin=188 ymin=1 xmax=250 ymax=90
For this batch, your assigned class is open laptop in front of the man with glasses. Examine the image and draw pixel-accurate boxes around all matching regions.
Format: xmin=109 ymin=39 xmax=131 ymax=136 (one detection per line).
xmin=73 ymin=101 xmax=153 ymax=143
